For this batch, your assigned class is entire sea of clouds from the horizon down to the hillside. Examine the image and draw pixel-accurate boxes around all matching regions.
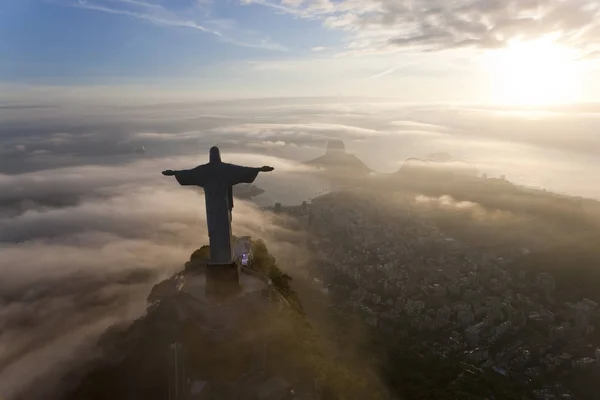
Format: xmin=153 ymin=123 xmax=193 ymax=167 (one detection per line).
xmin=0 ymin=95 xmax=600 ymax=399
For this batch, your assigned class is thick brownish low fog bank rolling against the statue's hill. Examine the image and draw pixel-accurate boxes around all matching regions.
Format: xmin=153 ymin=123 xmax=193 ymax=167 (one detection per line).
xmin=0 ymin=155 xmax=304 ymax=399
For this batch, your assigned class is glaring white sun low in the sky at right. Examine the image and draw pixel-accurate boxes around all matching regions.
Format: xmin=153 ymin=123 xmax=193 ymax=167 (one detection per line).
xmin=486 ymin=39 xmax=580 ymax=106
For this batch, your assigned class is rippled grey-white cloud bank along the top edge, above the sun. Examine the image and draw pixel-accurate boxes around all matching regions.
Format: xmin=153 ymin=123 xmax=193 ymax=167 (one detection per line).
xmin=242 ymin=0 xmax=600 ymax=54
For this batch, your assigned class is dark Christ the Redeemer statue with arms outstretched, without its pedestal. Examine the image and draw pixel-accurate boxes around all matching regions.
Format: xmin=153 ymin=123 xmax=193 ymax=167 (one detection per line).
xmin=163 ymin=146 xmax=274 ymax=265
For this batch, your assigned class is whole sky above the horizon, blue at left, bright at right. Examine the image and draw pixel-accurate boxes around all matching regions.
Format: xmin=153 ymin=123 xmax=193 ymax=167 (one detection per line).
xmin=0 ymin=0 xmax=600 ymax=105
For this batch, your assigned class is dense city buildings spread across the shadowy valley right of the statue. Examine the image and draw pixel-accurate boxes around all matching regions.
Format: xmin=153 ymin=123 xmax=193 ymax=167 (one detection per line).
xmin=270 ymin=188 xmax=600 ymax=399
